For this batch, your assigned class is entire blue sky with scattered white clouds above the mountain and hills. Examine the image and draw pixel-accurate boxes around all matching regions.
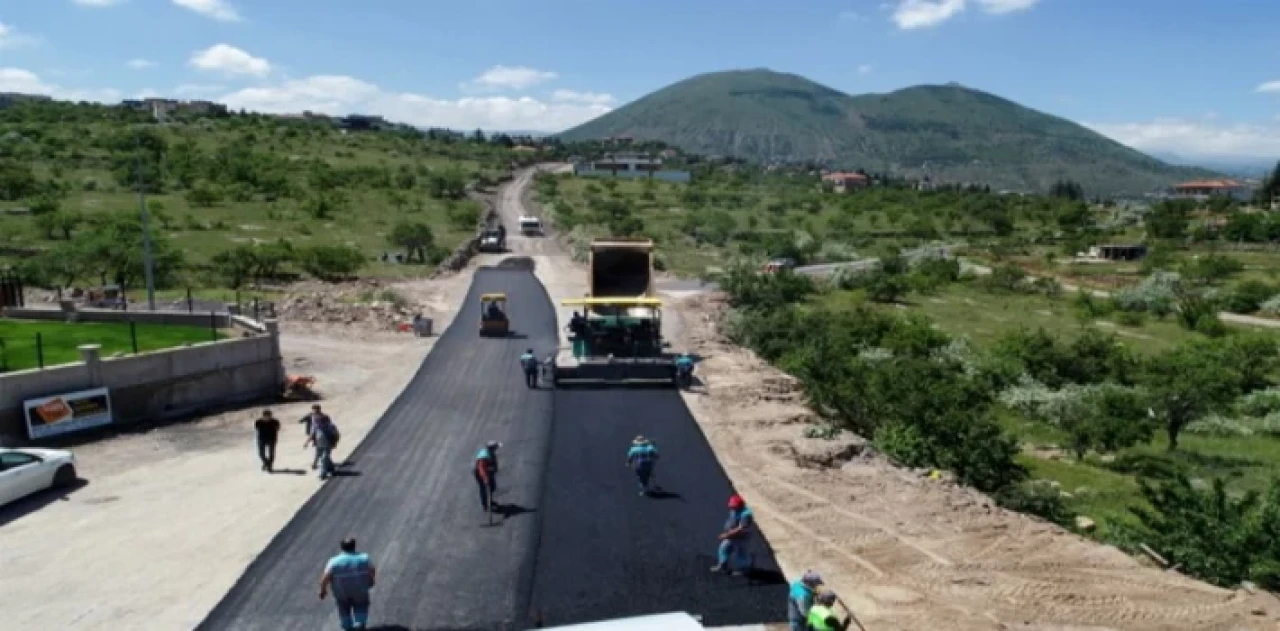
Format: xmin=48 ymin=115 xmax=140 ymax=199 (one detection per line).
xmin=0 ymin=0 xmax=1280 ymax=157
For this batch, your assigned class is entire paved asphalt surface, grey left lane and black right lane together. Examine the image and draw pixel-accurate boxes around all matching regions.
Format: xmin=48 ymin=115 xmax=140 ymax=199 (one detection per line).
xmin=200 ymin=263 xmax=786 ymax=631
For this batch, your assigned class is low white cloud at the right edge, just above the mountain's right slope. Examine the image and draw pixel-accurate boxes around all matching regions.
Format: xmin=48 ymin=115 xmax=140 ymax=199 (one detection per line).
xmin=1084 ymin=118 xmax=1280 ymax=157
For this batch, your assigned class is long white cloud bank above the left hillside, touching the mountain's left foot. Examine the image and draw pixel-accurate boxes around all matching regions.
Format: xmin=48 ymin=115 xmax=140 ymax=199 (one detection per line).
xmin=219 ymin=76 xmax=611 ymax=132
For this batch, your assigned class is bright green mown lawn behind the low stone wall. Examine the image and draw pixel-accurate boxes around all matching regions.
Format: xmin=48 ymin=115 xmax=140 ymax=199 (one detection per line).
xmin=0 ymin=319 xmax=223 ymax=370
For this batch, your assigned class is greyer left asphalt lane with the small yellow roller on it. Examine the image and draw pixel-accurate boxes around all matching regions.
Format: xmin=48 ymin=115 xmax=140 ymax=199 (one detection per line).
xmin=192 ymin=269 xmax=557 ymax=631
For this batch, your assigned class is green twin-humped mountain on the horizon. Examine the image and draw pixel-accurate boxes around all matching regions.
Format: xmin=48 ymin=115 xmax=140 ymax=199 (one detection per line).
xmin=559 ymin=69 xmax=1215 ymax=196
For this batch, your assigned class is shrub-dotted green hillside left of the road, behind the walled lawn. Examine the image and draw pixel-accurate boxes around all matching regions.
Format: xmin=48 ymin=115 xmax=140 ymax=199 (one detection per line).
xmin=0 ymin=102 xmax=540 ymax=287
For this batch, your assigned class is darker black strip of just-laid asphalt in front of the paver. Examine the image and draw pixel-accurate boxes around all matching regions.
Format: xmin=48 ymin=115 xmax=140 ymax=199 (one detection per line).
xmin=532 ymin=389 xmax=786 ymax=626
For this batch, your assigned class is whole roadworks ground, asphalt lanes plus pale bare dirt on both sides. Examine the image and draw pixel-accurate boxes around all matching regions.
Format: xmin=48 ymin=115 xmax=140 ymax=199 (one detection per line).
xmin=0 ymin=165 xmax=1280 ymax=631
